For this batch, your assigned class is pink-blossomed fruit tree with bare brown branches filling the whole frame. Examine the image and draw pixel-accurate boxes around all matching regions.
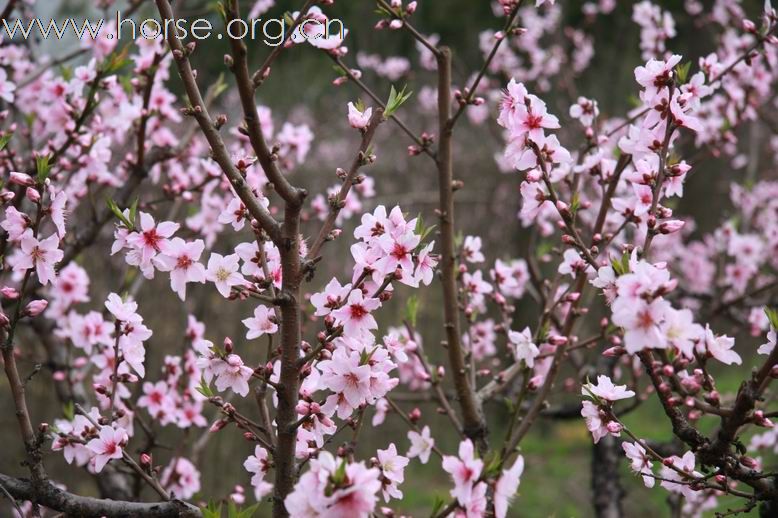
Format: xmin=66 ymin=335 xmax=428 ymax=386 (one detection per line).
xmin=0 ymin=0 xmax=778 ymax=518
